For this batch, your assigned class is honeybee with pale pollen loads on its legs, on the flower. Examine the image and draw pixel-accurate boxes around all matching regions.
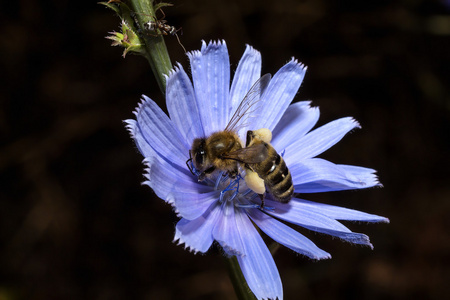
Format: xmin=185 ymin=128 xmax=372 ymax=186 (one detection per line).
xmin=186 ymin=74 xmax=294 ymax=209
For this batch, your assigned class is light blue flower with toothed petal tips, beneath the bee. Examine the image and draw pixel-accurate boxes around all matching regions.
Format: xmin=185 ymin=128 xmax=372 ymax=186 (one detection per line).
xmin=126 ymin=42 xmax=389 ymax=299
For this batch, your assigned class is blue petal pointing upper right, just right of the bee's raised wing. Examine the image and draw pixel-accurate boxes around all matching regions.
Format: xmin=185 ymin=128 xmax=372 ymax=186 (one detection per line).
xmin=249 ymin=59 xmax=306 ymax=130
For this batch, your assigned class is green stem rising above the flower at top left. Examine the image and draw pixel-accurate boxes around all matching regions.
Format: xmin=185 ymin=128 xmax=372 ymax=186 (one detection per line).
xmin=129 ymin=0 xmax=172 ymax=94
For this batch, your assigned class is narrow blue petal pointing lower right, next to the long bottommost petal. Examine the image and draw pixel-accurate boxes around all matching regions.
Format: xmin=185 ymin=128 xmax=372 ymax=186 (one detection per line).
xmin=249 ymin=209 xmax=331 ymax=259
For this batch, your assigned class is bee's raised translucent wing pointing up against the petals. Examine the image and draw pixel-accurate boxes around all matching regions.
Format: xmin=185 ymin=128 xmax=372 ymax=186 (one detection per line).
xmin=225 ymin=74 xmax=272 ymax=131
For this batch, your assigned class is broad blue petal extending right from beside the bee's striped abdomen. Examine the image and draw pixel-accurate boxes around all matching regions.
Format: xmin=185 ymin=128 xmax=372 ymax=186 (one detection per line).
xmin=286 ymin=156 xmax=380 ymax=193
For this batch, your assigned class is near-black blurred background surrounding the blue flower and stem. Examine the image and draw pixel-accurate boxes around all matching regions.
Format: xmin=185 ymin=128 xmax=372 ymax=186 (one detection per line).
xmin=0 ymin=0 xmax=450 ymax=300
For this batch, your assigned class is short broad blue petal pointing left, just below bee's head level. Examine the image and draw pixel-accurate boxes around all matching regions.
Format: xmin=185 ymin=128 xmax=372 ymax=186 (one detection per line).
xmin=144 ymin=157 xmax=211 ymax=203
